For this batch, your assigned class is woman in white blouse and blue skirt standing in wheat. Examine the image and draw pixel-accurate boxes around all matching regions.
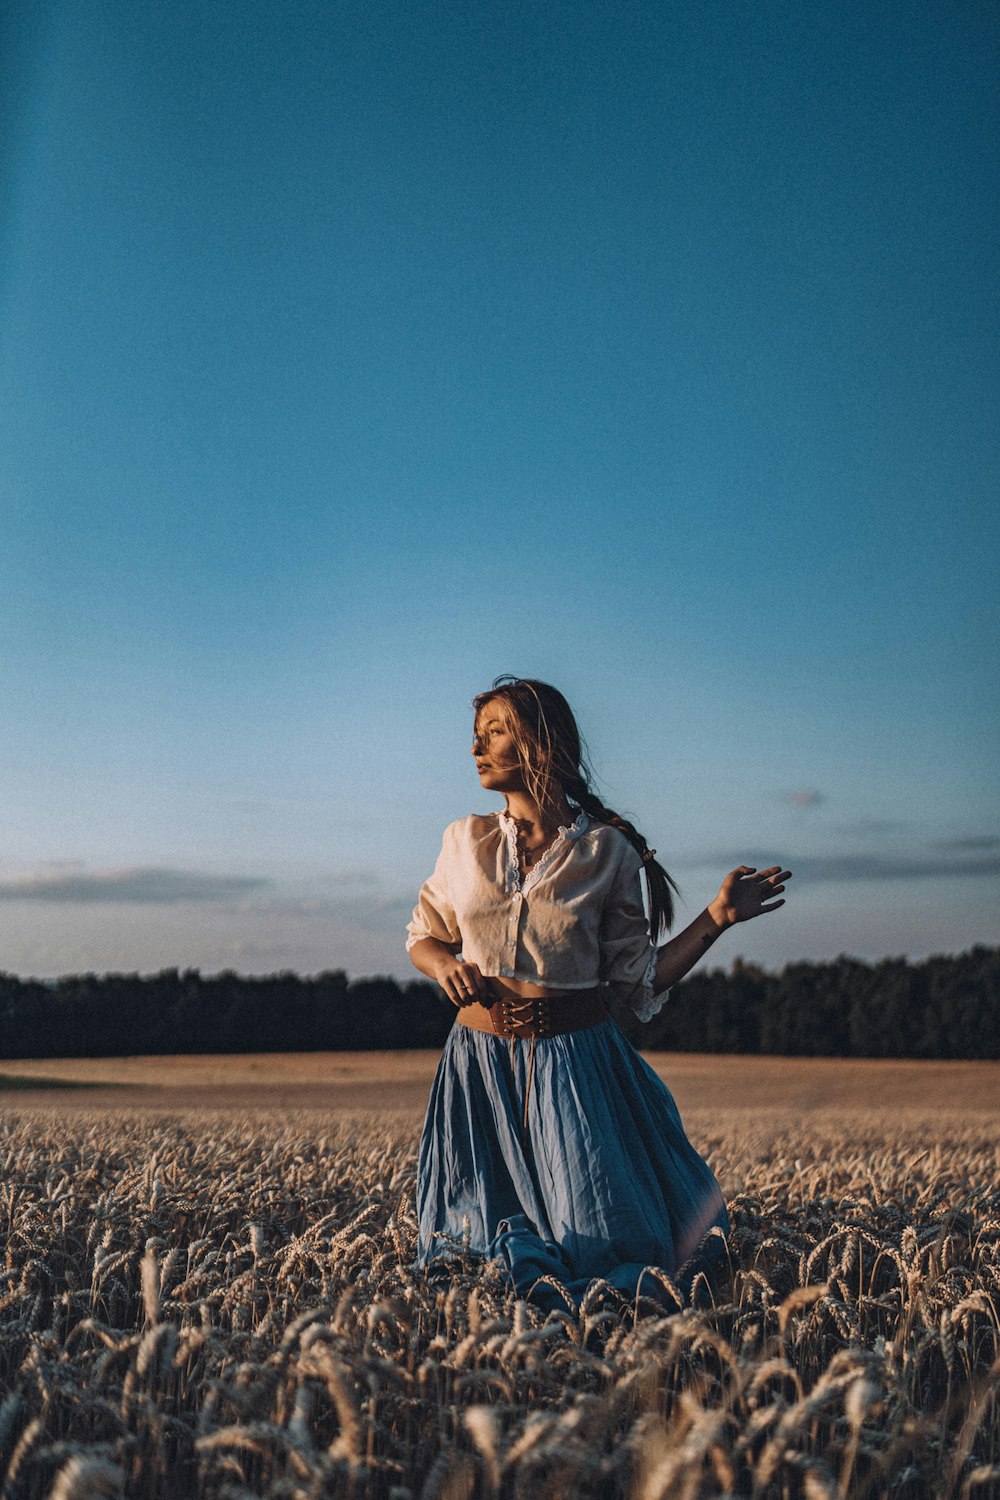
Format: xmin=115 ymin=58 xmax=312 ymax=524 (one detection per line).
xmin=406 ymin=677 xmax=789 ymax=1305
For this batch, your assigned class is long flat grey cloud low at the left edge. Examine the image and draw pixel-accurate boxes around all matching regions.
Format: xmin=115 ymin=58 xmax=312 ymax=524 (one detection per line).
xmin=0 ymin=861 xmax=271 ymax=905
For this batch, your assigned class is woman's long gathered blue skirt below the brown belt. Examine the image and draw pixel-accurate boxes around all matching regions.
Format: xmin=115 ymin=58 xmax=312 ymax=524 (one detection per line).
xmin=417 ymin=1020 xmax=729 ymax=1307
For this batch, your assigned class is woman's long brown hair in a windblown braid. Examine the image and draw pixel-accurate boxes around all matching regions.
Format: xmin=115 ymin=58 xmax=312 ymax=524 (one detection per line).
xmin=472 ymin=675 xmax=676 ymax=942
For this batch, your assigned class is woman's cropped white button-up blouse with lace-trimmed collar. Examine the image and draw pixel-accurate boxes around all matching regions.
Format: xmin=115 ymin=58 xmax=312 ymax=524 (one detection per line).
xmin=406 ymin=812 xmax=669 ymax=1022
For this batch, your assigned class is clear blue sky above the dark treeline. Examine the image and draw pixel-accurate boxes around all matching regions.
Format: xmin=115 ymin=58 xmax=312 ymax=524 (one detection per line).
xmin=0 ymin=0 xmax=1000 ymax=975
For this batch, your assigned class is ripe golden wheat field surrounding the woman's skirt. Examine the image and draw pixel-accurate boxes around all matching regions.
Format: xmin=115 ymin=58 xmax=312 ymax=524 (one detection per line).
xmin=0 ymin=1070 xmax=1000 ymax=1500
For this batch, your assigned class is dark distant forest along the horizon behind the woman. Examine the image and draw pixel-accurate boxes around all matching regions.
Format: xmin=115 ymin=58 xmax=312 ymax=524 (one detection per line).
xmin=0 ymin=948 xmax=1000 ymax=1059
